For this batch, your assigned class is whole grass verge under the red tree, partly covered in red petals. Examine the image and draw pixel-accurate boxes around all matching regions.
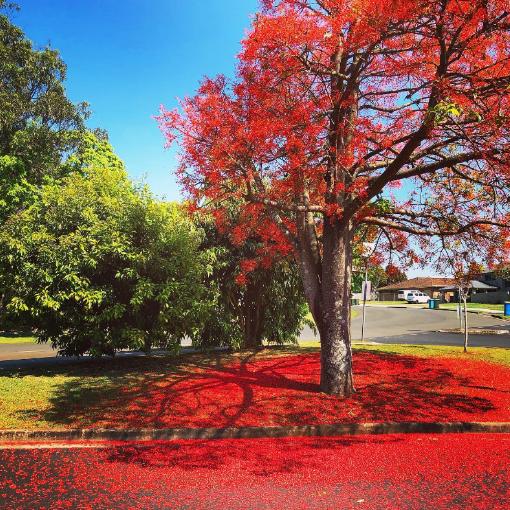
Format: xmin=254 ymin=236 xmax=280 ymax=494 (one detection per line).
xmin=0 ymin=342 xmax=510 ymax=429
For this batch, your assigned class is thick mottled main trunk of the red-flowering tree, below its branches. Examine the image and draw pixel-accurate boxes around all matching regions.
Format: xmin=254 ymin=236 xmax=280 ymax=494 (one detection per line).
xmin=319 ymin=219 xmax=355 ymax=397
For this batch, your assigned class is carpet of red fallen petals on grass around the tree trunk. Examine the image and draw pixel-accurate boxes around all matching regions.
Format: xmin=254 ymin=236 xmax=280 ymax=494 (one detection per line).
xmin=30 ymin=351 xmax=510 ymax=428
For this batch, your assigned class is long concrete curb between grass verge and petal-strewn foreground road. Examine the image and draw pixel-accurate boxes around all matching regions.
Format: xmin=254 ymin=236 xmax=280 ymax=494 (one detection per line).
xmin=0 ymin=422 xmax=510 ymax=444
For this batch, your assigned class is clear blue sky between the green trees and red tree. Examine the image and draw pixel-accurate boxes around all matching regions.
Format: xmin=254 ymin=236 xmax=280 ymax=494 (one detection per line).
xmin=13 ymin=0 xmax=258 ymax=200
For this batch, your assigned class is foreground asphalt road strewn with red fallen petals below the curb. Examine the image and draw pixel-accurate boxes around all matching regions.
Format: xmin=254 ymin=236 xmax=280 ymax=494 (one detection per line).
xmin=0 ymin=434 xmax=510 ymax=510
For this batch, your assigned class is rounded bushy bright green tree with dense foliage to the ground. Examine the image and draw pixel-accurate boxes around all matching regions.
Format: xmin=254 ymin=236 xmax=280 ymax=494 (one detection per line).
xmin=0 ymin=139 xmax=202 ymax=356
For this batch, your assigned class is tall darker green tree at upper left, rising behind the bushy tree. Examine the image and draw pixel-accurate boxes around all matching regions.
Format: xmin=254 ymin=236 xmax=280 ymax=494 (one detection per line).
xmin=0 ymin=0 xmax=90 ymax=223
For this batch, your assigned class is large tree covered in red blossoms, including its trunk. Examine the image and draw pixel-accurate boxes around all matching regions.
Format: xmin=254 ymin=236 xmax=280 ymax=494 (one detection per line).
xmin=158 ymin=0 xmax=510 ymax=396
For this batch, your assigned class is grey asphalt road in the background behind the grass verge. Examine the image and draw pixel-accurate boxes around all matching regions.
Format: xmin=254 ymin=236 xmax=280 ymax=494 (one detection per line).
xmin=0 ymin=306 xmax=510 ymax=368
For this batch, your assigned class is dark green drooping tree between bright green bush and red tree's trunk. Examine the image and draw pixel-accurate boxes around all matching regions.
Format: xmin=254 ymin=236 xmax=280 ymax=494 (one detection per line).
xmin=194 ymin=210 xmax=315 ymax=349
